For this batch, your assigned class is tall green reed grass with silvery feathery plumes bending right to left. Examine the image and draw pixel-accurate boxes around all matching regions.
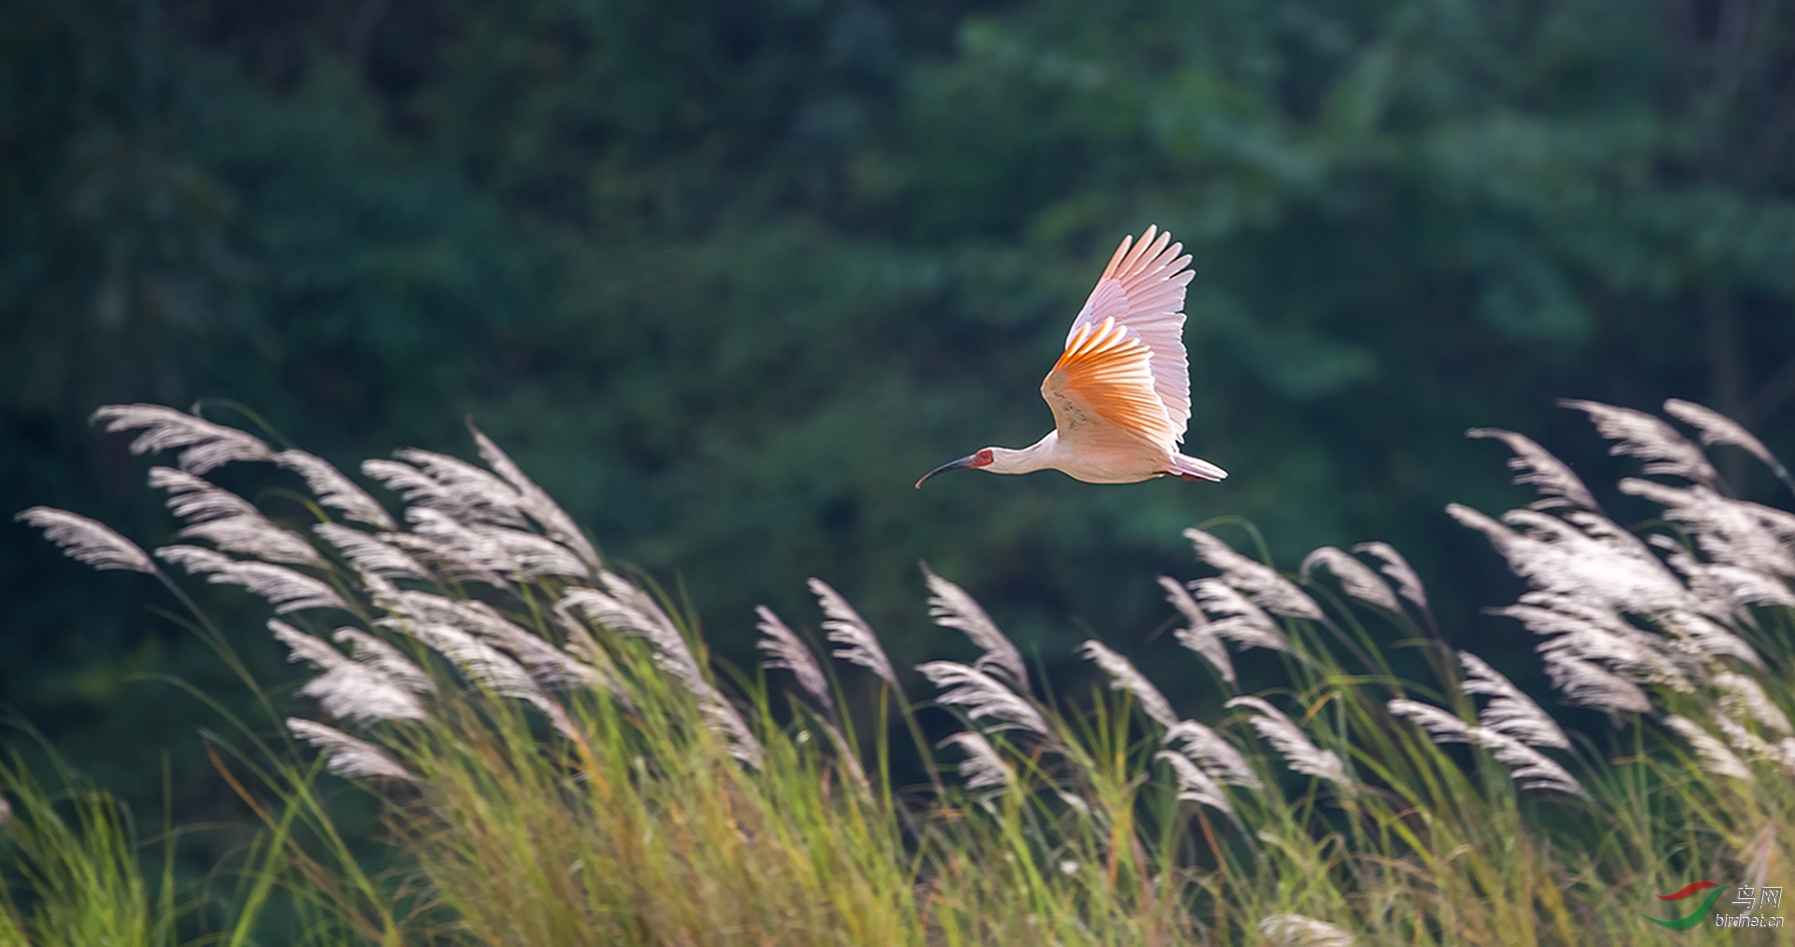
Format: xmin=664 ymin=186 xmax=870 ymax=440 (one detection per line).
xmin=14 ymin=402 xmax=1795 ymax=945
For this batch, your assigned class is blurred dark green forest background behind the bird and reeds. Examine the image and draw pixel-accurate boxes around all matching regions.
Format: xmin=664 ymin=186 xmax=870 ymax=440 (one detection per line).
xmin=0 ymin=0 xmax=1795 ymax=835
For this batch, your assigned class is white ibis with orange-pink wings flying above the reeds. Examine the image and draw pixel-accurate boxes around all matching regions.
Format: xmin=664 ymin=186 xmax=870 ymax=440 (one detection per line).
xmin=915 ymin=226 xmax=1228 ymax=488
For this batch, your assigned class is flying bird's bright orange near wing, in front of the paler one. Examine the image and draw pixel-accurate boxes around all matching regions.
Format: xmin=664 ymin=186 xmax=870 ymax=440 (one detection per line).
xmin=1041 ymin=316 xmax=1183 ymax=454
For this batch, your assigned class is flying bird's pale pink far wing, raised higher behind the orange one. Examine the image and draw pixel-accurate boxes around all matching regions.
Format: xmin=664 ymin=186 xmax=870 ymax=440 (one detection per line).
xmin=1055 ymin=226 xmax=1195 ymax=448
